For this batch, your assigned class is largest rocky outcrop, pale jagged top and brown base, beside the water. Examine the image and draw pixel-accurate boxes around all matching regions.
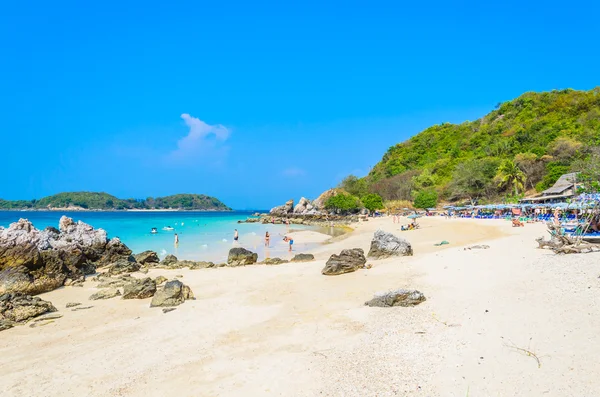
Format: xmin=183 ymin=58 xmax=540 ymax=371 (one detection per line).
xmin=0 ymin=216 xmax=131 ymax=294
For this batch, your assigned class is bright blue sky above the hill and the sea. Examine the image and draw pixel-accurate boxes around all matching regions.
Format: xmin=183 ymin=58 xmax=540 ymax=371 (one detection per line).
xmin=0 ymin=0 xmax=600 ymax=209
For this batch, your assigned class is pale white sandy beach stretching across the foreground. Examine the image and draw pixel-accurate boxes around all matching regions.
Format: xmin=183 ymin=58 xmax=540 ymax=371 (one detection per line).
xmin=0 ymin=218 xmax=600 ymax=397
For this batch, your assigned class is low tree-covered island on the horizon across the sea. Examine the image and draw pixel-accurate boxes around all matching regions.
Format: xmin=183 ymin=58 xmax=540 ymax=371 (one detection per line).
xmin=0 ymin=192 xmax=231 ymax=211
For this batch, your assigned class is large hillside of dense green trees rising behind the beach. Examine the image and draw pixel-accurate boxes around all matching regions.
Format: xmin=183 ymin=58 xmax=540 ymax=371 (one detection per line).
xmin=340 ymin=87 xmax=600 ymax=202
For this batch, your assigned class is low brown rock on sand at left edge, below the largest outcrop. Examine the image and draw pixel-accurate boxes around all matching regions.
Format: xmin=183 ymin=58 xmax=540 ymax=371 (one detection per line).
xmin=0 ymin=292 xmax=56 ymax=331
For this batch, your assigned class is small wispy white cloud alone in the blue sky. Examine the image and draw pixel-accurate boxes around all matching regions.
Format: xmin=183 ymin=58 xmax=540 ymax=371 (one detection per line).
xmin=169 ymin=113 xmax=231 ymax=160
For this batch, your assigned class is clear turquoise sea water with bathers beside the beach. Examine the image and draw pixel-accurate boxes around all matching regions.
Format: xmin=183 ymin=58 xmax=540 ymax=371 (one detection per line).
xmin=0 ymin=211 xmax=318 ymax=262
